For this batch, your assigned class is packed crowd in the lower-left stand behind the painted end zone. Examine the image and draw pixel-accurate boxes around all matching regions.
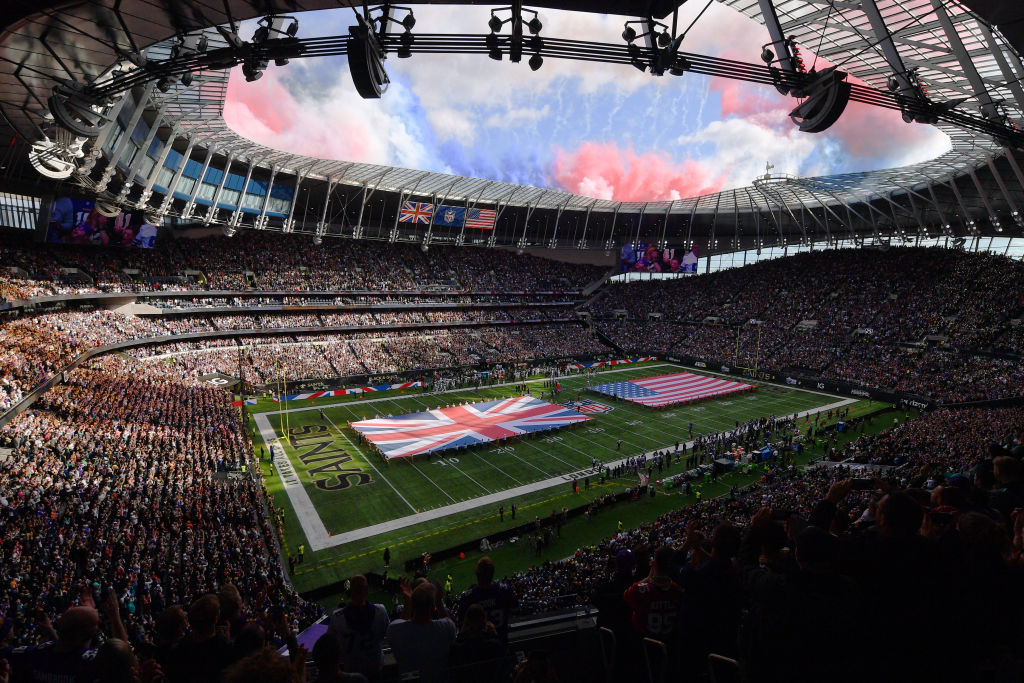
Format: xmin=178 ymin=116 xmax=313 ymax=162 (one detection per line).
xmin=0 ymin=356 xmax=318 ymax=655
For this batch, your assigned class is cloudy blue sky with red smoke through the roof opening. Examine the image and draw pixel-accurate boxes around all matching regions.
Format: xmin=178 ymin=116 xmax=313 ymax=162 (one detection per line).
xmin=224 ymin=2 xmax=949 ymax=202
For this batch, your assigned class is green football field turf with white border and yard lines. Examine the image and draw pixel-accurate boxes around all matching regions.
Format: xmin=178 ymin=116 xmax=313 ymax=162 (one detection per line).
xmin=250 ymin=362 xmax=878 ymax=590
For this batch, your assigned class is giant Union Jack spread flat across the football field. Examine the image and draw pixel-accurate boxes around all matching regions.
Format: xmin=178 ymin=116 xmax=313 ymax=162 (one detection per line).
xmin=350 ymin=396 xmax=592 ymax=460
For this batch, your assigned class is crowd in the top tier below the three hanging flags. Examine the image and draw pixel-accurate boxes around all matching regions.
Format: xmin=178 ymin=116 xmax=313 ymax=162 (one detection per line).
xmin=0 ymin=230 xmax=604 ymax=300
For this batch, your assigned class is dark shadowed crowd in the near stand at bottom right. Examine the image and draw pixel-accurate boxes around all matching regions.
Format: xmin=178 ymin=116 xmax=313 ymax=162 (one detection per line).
xmin=497 ymin=408 xmax=1024 ymax=682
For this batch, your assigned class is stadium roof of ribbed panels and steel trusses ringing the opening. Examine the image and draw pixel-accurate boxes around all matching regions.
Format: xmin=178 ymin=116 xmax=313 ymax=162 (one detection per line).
xmin=0 ymin=0 xmax=1024 ymax=242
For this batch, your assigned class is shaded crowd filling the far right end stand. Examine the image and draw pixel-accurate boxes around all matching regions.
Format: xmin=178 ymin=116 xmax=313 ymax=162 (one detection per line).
xmin=588 ymin=248 xmax=1024 ymax=401
